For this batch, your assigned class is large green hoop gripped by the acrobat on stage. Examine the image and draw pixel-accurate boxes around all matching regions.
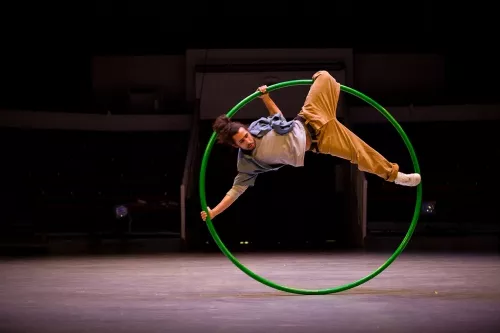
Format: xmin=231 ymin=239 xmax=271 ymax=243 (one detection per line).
xmin=199 ymin=80 xmax=422 ymax=295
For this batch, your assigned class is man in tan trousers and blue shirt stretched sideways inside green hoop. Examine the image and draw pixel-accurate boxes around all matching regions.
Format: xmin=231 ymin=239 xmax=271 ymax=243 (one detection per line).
xmin=201 ymin=71 xmax=421 ymax=221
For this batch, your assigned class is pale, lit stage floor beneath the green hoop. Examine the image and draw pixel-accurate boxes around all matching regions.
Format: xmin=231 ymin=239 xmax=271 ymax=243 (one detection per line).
xmin=0 ymin=253 xmax=500 ymax=333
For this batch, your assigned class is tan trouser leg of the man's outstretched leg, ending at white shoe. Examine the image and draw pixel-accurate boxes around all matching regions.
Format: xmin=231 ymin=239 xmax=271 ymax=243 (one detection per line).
xmin=318 ymin=119 xmax=399 ymax=182
